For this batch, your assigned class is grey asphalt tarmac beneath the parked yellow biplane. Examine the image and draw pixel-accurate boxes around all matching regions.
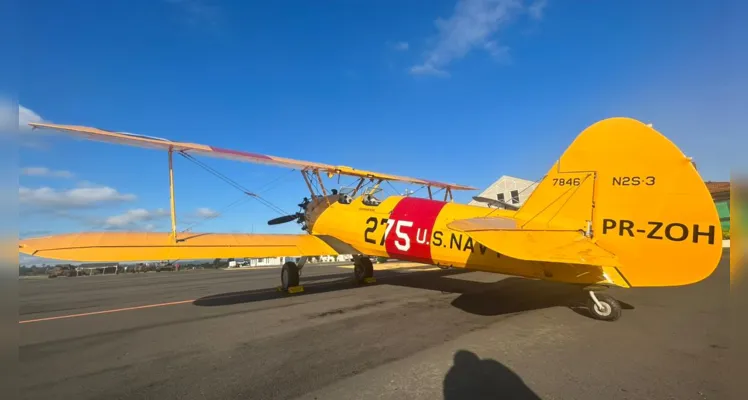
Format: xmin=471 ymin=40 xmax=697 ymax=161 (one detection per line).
xmin=19 ymin=253 xmax=729 ymax=400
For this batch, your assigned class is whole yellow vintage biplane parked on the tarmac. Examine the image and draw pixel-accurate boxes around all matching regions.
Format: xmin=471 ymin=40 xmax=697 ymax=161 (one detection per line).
xmin=19 ymin=118 xmax=722 ymax=321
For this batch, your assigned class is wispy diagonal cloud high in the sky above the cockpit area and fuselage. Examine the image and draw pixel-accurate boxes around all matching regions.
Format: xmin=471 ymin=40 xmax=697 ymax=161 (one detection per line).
xmin=410 ymin=0 xmax=546 ymax=76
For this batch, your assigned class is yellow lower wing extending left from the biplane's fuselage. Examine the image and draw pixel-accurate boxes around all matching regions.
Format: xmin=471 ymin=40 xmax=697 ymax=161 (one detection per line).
xmin=18 ymin=232 xmax=338 ymax=262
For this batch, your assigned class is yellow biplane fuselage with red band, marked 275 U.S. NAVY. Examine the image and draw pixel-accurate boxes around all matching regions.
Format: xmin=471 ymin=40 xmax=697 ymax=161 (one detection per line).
xmin=309 ymin=196 xmax=612 ymax=283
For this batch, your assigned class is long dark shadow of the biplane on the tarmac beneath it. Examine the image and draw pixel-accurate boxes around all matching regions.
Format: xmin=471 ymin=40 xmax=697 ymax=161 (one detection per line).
xmin=193 ymin=270 xmax=633 ymax=317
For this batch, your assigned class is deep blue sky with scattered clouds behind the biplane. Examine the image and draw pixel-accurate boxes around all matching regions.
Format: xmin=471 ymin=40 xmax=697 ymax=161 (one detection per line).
xmin=8 ymin=0 xmax=748 ymax=248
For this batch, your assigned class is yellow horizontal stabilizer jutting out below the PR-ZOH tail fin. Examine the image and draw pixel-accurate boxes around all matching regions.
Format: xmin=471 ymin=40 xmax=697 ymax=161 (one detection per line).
xmin=448 ymin=217 xmax=620 ymax=267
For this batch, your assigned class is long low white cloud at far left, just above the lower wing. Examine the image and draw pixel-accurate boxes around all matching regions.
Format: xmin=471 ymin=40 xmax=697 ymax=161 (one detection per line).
xmin=18 ymin=186 xmax=135 ymax=210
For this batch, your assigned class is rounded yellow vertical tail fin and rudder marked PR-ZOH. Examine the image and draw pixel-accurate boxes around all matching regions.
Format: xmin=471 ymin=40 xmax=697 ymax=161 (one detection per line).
xmin=515 ymin=118 xmax=722 ymax=286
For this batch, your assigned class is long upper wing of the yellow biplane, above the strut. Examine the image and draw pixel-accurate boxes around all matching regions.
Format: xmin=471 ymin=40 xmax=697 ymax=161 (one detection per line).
xmin=29 ymin=122 xmax=475 ymax=190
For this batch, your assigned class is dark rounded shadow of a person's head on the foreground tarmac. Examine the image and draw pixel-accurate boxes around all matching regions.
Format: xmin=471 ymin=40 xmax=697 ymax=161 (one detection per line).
xmin=444 ymin=350 xmax=540 ymax=400
